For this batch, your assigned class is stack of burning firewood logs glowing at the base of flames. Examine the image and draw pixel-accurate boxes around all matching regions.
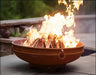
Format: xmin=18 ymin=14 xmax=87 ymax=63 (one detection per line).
xmin=31 ymin=34 xmax=64 ymax=48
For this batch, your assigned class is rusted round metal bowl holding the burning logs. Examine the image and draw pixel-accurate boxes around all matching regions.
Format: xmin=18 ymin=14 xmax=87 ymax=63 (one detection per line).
xmin=12 ymin=39 xmax=84 ymax=66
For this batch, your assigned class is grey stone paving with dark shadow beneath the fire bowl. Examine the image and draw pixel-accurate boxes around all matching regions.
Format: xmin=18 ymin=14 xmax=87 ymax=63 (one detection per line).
xmin=1 ymin=54 xmax=96 ymax=75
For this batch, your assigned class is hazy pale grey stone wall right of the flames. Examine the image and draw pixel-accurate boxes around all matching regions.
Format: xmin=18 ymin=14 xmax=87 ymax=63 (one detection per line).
xmin=75 ymin=15 xmax=96 ymax=33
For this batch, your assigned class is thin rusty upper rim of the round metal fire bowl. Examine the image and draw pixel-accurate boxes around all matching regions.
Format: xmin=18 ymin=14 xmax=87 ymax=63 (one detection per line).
xmin=12 ymin=38 xmax=84 ymax=50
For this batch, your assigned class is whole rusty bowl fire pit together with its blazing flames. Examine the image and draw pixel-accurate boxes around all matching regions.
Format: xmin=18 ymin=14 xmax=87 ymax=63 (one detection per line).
xmin=12 ymin=0 xmax=83 ymax=66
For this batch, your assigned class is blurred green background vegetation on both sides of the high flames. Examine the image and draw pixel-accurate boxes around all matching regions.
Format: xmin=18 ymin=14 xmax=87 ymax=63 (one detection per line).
xmin=0 ymin=0 xmax=95 ymax=20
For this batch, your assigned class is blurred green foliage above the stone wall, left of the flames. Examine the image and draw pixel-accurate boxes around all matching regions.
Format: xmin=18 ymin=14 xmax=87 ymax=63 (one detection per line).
xmin=0 ymin=0 xmax=52 ymax=20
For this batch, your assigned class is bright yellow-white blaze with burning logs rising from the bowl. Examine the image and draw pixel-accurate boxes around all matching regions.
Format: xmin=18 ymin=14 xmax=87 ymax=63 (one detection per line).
xmin=24 ymin=0 xmax=83 ymax=48
